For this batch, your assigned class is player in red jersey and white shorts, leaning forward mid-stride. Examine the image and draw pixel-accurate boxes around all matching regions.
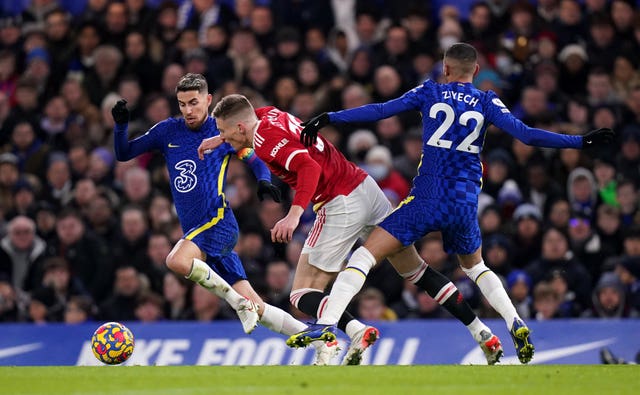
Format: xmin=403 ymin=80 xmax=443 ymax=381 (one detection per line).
xmin=198 ymin=95 xmax=502 ymax=365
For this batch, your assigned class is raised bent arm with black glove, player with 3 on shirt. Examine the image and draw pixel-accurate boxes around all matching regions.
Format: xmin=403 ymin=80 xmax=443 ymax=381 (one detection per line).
xmin=111 ymin=99 xmax=158 ymax=161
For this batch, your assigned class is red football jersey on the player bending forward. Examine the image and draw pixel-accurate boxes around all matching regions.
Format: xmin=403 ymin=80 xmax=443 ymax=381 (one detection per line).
xmin=253 ymin=107 xmax=367 ymax=209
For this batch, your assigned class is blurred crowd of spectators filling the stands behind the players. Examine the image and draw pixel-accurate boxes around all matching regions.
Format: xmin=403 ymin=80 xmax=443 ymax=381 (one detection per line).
xmin=0 ymin=0 xmax=640 ymax=323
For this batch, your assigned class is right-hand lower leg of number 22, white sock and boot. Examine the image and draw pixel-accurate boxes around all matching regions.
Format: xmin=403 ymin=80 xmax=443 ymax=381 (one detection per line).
xmin=458 ymin=248 xmax=534 ymax=363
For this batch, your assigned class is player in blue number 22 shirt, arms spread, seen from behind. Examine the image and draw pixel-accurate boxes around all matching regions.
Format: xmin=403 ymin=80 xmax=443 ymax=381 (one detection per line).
xmin=300 ymin=43 xmax=613 ymax=363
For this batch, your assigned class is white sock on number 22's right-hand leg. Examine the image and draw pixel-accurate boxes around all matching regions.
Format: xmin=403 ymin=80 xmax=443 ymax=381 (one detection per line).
xmin=462 ymin=261 xmax=520 ymax=330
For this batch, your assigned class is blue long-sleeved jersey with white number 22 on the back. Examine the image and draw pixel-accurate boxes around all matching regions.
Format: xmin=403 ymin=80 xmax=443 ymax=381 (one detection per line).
xmin=329 ymin=80 xmax=582 ymax=203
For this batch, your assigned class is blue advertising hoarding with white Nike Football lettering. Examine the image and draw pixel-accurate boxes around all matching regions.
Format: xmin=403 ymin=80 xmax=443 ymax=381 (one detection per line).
xmin=0 ymin=320 xmax=640 ymax=366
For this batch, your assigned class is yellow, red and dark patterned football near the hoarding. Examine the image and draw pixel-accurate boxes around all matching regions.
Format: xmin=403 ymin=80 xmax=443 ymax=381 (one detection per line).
xmin=91 ymin=322 xmax=134 ymax=365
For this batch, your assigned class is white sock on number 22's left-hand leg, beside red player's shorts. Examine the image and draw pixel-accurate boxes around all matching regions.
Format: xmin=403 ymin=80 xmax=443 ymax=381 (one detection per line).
xmin=317 ymin=247 xmax=376 ymax=325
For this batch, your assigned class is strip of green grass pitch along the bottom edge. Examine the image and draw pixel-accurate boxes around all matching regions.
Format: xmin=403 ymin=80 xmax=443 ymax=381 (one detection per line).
xmin=0 ymin=365 xmax=640 ymax=395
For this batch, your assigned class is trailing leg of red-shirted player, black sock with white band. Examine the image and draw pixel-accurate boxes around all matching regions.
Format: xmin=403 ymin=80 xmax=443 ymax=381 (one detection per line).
xmin=388 ymin=245 xmax=503 ymax=365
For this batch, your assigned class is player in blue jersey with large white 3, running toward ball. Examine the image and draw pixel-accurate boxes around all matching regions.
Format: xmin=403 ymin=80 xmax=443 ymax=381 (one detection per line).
xmin=112 ymin=73 xmax=335 ymax=365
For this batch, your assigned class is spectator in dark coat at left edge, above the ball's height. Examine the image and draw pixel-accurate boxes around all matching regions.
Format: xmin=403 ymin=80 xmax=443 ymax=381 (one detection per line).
xmin=0 ymin=216 xmax=46 ymax=291
